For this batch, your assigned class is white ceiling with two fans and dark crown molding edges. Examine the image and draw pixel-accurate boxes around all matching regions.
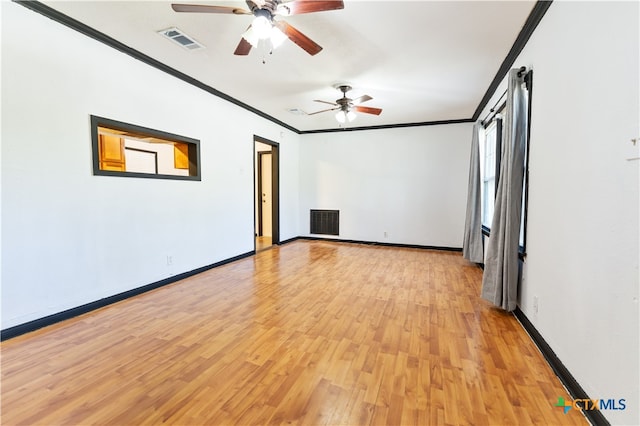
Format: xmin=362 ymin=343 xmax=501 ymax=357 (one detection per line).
xmin=42 ymin=0 xmax=535 ymax=131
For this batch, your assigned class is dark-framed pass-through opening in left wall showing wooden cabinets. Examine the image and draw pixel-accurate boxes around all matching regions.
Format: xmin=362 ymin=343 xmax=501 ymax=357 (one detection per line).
xmin=91 ymin=116 xmax=200 ymax=180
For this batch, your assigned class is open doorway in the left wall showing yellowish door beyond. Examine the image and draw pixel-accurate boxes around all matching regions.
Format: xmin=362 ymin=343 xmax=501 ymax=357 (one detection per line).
xmin=254 ymin=136 xmax=280 ymax=252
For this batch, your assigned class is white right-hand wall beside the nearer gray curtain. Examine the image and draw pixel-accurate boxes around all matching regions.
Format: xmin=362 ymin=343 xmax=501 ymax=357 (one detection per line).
xmin=478 ymin=1 xmax=640 ymax=424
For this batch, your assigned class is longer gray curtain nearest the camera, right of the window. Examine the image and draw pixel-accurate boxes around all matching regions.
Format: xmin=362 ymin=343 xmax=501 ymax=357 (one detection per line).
xmin=481 ymin=69 xmax=527 ymax=311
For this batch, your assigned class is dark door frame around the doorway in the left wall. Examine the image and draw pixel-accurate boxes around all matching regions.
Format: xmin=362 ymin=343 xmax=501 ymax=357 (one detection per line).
xmin=253 ymin=135 xmax=280 ymax=248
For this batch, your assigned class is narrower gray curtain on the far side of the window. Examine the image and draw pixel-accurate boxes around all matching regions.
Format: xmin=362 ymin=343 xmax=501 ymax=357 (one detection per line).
xmin=462 ymin=121 xmax=484 ymax=263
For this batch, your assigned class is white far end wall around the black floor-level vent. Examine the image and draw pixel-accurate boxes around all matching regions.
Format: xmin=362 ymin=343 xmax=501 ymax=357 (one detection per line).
xmin=300 ymin=124 xmax=472 ymax=247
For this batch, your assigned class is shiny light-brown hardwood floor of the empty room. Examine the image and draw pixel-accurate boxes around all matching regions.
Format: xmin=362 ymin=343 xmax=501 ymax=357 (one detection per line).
xmin=1 ymin=241 xmax=586 ymax=425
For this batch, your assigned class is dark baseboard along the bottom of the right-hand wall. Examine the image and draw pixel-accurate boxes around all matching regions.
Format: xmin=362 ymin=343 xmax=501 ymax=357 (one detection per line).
xmin=513 ymin=308 xmax=610 ymax=426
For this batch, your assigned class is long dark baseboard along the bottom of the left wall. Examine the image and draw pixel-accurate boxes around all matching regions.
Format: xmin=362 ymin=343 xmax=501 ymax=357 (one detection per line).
xmin=0 ymin=251 xmax=255 ymax=341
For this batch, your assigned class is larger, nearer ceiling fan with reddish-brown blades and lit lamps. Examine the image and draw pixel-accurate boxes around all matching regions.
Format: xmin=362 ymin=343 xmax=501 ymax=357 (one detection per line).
xmin=171 ymin=0 xmax=344 ymax=55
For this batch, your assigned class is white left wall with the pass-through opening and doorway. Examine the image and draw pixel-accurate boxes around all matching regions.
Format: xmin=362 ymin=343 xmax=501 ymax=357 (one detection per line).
xmin=1 ymin=2 xmax=299 ymax=328
